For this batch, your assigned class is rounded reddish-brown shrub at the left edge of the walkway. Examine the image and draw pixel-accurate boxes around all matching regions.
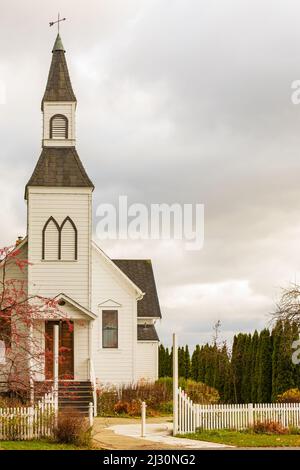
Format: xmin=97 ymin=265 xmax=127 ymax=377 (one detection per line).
xmin=54 ymin=411 xmax=91 ymax=447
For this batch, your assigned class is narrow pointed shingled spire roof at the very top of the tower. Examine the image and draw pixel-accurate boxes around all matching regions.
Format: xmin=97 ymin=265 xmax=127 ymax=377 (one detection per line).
xmin=42 ymin=34 xmax=76 ymax=110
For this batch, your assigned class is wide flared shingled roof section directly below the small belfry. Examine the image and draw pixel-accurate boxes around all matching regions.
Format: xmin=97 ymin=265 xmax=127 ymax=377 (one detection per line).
xmin=26 ymin=147 xmax=94 ymax=196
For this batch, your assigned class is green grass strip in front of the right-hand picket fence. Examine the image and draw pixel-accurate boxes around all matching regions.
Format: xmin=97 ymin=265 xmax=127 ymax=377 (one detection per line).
xmin=183 ymin=430 xmax=300 ymax=447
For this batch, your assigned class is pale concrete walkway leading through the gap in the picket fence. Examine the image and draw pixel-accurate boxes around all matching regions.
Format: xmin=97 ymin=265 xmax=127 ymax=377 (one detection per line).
xmin=93 ymin=418 xmax=230 ymax=450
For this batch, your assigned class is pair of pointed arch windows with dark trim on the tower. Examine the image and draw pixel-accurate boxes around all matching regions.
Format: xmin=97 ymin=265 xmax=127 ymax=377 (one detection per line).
xmin=42 ymin=217 xmax=78 ymax=261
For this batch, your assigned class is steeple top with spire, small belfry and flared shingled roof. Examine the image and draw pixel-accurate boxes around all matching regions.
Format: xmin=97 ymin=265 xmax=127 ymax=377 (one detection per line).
xmin=25 ymin=34 xmax=94 ymax=198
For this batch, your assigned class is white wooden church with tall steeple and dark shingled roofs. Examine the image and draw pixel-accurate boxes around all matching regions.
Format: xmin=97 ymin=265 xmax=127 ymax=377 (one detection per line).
xmin=0 ymin=35 xmax=161 ymax=406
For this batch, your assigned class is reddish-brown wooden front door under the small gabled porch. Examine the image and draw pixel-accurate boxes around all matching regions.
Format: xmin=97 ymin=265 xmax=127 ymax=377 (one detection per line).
xmin=45 ymin=321 xmax=74 ymax=380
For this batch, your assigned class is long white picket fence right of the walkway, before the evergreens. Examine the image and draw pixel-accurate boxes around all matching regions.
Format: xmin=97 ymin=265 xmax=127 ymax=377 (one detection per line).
xmin=177 ymin=388 xmax=300 ymax=434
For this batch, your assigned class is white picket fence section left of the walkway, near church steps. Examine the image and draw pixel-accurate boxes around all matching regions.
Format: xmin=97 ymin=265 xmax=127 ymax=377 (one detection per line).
xmin=0 ymin=392 xmax=56 ymax=440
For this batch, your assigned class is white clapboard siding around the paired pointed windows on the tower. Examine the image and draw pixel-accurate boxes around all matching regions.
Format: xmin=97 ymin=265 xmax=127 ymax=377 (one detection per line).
xmin=28 ymin=187 xmax=92 ymax=309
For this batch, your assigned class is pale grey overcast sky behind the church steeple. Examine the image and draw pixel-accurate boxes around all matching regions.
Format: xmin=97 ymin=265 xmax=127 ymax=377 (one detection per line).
xmin=0 ymin=0 xmax=300 ymax=345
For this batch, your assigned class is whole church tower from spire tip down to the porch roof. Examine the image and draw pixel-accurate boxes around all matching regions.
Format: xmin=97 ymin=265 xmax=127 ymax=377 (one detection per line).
xmin=25 ymin=34 xmax=94 ymax=308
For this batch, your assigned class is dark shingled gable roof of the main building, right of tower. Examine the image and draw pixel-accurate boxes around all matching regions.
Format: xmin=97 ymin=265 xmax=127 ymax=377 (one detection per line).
xmin=112 ymin=259 xmax=161 ymax=318
